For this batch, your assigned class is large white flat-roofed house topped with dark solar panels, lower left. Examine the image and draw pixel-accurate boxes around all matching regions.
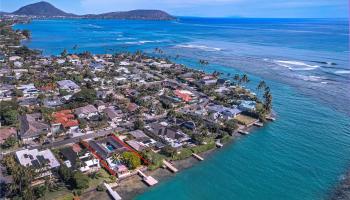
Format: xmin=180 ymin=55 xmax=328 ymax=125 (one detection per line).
xmin=16 ymin=149 xmax=60 ymax=178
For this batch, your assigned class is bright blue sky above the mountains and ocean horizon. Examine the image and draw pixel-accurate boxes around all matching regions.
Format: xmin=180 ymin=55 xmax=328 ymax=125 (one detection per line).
xmin=0 ymin=0 xmax=349 ymax=18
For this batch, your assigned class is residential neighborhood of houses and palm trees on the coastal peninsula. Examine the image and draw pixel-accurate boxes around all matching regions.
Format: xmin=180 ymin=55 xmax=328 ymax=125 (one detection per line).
xmin=0 ymin=16 xmax=273 ymax=198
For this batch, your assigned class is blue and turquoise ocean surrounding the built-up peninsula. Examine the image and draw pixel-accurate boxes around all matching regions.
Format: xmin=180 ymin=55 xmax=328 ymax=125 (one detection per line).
xmin=15 ymin=17 xmax=350 ymax=200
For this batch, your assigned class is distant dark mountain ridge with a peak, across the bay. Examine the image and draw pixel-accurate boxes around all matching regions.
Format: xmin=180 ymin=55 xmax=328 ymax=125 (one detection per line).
xmin=11 ymin=1 xmax=175 ymax=20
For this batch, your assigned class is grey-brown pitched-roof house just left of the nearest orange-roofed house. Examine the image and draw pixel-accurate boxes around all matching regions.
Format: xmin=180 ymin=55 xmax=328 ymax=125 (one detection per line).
xmin=19 ymin=113 xmax=50 ymax=143
